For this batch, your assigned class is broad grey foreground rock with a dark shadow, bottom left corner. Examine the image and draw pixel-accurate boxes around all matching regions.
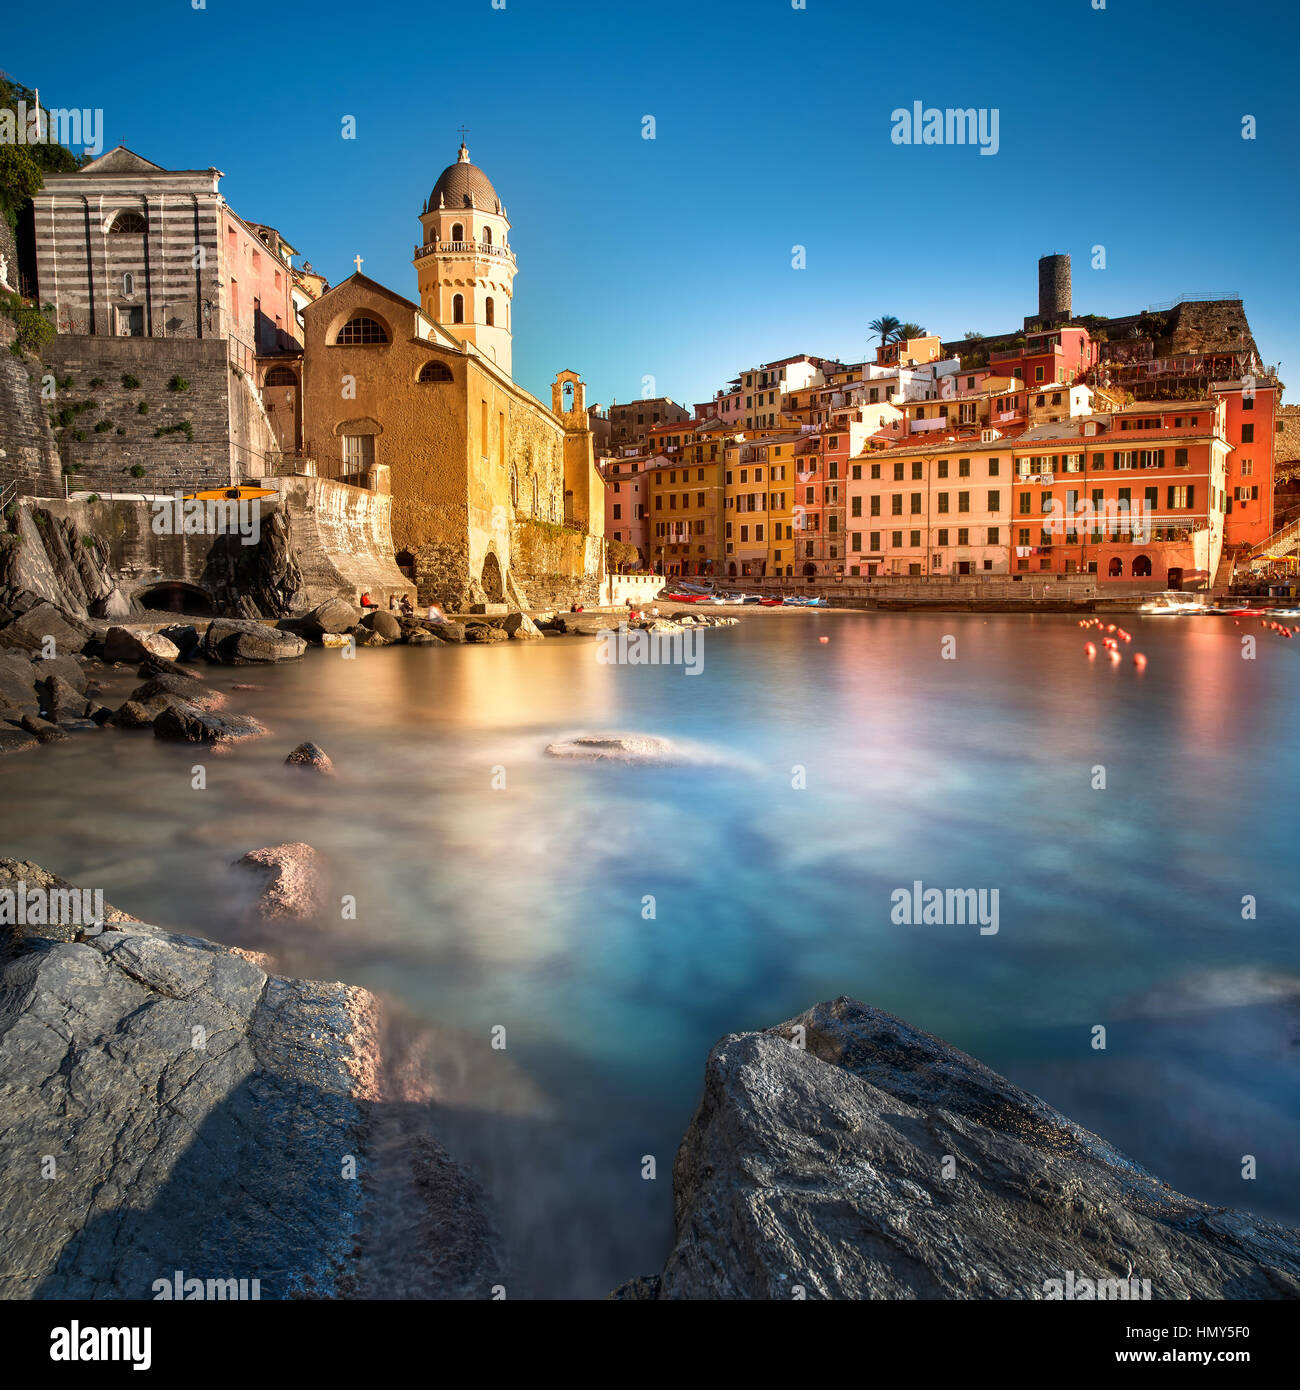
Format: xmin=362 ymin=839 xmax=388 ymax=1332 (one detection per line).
xmin=0 ymin=860 xmax=502 ymax=1300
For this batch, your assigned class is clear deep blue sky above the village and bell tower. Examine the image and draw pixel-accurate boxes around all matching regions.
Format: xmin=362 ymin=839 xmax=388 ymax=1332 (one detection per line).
xmin=0 ymin=0 xmax=1300 ymax=404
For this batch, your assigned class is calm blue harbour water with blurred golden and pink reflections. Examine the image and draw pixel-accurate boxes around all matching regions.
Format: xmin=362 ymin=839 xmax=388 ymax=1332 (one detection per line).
xmin=0 ymin=612 xmax=1300 ymax=1297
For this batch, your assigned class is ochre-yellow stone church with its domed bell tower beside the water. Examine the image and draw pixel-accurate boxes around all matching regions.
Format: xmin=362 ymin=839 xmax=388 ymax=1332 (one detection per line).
xmin=302 ymin=145 xmax=605 ymax=610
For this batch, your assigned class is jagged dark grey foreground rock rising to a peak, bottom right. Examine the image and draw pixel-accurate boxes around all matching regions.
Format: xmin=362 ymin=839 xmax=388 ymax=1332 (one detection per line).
xmin=616 ymin=998 xmax=1300 ymax=1300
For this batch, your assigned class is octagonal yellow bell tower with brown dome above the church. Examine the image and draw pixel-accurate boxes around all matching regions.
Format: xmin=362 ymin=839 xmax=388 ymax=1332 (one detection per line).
xmin=414 ymin=132 xmax=514 ymax=377
